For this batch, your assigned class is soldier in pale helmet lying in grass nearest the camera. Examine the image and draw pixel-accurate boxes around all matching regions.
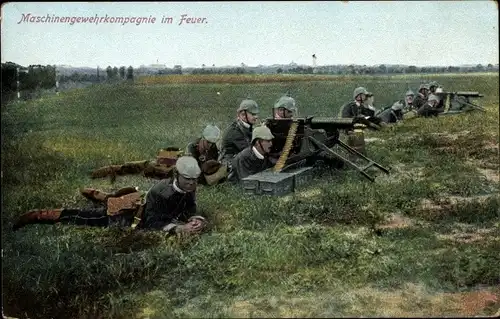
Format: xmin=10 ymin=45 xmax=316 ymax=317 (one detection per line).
xmin=14 ymin=156 xmax=206 ymax=234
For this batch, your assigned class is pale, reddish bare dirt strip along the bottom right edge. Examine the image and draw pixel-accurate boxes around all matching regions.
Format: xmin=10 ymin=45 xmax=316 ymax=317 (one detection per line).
xmin=228 ymin=284 xmax=500 ymax=318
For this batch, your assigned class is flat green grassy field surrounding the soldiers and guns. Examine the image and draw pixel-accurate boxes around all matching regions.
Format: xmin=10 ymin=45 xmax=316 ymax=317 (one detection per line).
xmin=1 ymin=74 xmax=500 ymax=319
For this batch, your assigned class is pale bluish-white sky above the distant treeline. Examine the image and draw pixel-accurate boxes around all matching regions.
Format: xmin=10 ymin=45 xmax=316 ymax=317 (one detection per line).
xmin=1 ymin=0 xmax=499 ymax=67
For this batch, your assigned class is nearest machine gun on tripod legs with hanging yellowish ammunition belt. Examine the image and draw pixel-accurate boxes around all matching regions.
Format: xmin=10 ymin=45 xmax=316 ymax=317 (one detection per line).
xmin=265 ymin=116 xmax=389 ymax=182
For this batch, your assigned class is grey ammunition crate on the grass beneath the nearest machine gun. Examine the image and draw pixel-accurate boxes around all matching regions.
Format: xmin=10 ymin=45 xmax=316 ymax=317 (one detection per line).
xmin=241 ymin=167 xmax=313 ymax=196
